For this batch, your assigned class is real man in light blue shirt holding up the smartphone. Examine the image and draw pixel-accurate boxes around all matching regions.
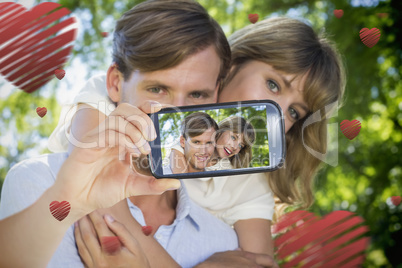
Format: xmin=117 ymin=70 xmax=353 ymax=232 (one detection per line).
xmin=0 ymin=0 xmax=274 ymax=267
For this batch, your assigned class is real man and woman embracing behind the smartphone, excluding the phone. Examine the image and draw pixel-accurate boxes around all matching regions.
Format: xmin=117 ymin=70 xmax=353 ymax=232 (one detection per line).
xmin=0 ymin=0 xmax=344 ymax=267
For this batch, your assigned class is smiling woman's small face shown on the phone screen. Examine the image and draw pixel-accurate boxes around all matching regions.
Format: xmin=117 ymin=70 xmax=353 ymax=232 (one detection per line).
xmin=216 ymin=130 xmax=244 ymax=158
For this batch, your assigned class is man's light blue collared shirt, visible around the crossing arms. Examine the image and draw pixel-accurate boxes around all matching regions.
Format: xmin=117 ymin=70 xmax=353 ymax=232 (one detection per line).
xmin=0 ymin=153 xmax=238 ymax=268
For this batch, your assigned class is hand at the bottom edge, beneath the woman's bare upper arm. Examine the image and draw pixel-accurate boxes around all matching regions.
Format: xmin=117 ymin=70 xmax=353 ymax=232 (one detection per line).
xmin=196 ymin=250 xmax=279 ymax=268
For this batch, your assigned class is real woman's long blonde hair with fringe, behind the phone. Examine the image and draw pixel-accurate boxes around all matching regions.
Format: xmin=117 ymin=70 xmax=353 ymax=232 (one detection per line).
xmin=225 ymin=17 xmax=345 ymax=213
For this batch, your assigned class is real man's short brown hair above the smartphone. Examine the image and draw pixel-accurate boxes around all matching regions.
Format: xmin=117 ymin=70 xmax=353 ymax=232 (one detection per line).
xmin=113 ymin=0 xmax=230 ymax=85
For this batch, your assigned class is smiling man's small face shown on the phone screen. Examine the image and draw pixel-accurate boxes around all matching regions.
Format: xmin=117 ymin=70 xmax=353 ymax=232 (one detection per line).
xmin=180 ymin=127 xmax=215 ymax=172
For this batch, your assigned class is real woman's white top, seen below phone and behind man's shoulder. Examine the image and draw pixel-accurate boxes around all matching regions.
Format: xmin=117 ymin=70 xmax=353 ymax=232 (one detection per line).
xmin=48 ymin=75 xmax=275 ymax=225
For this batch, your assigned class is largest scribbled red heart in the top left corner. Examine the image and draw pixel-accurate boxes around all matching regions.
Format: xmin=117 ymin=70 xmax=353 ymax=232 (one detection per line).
xmin=0 ymin=2 xmax=77 ymax=93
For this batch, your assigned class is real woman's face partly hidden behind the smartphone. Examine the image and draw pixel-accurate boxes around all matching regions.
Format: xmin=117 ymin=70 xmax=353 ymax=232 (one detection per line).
xmin=218 ymin=60 xmax=309 ymax=132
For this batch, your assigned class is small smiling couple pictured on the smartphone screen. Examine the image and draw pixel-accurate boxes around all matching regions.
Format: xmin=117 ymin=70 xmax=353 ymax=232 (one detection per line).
xmin=164 ymin=112 xmax=255 ymax=174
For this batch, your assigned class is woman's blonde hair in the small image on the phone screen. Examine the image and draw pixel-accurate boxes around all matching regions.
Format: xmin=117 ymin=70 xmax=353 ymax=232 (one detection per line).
xmin=215 ymin=116 xmax=255 ymax=168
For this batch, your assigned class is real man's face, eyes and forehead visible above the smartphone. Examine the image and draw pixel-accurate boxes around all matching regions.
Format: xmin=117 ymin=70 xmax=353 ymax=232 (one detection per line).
xmin=113 ymin=46 xmax=221 ymax=106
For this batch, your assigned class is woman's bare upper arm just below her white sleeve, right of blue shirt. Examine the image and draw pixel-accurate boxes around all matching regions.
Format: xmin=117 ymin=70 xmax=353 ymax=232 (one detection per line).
xmin=234 ymin=219 xmax=274 ymax=257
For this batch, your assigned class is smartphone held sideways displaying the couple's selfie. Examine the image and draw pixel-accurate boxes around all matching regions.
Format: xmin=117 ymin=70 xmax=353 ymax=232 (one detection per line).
xmin=148 ymin=100 xmax=286 ymax=179
